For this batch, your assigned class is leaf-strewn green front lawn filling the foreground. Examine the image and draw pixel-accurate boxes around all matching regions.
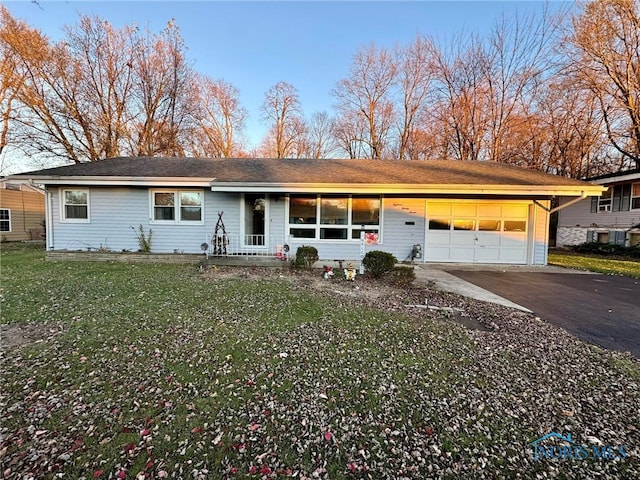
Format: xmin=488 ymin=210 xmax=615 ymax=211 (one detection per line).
xmin=0 ymin=248 xmax=640 ymax=479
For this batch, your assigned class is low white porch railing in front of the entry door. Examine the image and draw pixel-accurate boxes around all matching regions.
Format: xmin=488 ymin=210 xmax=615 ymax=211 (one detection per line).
xmin=209 ymin=234 xmax=287 ymax=257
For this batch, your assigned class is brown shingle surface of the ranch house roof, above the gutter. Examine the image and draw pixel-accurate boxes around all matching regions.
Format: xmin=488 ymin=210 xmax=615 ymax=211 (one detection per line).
xmin=16 ymin=157 xmax=600 ymax=186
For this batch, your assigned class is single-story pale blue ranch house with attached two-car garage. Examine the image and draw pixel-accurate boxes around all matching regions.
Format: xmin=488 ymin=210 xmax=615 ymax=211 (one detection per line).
xmin=11 ymin=158 xmax=603 ymax=265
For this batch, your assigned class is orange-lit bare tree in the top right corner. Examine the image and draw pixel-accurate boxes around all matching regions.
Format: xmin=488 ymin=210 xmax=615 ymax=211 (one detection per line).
xmin=569 ymin=0 xmax=640 ymax=168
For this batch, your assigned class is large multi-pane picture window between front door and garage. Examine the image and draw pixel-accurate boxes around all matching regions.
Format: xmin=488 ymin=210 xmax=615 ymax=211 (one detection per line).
xmin=289 ymin=195 xmax=381 ymax=240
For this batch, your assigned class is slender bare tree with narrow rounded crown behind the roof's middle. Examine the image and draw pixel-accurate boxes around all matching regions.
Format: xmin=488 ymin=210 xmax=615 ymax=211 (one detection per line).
xmin=261 ymin=82 xmax=303 ymax=158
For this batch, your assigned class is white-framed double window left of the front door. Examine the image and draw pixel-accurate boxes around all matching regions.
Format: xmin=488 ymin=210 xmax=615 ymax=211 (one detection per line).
xmin=151 ymin=190 xmax=202 ymax=223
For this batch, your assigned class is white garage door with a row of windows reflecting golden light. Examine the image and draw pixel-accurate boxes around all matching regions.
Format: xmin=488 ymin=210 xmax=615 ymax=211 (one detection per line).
xmin=425 ymin=202 xmax=529 ymax=264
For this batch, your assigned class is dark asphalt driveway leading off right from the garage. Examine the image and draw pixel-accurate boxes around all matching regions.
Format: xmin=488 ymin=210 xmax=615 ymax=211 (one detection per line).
xmin=447 ymin=269 xmax=640 ymax=358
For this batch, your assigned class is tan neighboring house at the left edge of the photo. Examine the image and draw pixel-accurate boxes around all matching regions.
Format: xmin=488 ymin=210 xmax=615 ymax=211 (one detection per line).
xmin=0 ymin=179 xmax=45 ymax=242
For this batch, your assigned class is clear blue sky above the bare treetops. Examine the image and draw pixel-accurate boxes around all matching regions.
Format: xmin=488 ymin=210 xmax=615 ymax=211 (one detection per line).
xmin=3 ymin=0 xmax=562 ymax=169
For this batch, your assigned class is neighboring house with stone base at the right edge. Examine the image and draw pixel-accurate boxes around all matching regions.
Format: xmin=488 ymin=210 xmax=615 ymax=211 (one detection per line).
xmin=556 ymin=170 xmax=640 ymax=246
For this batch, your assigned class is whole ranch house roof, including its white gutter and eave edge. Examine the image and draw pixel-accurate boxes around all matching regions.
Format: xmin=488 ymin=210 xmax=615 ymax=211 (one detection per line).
xmin=15 ymin=157 xmax=603 ymax=196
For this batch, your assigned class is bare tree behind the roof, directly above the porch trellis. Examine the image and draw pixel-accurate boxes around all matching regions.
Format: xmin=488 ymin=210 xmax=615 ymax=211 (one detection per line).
xmin=192 ymin=76 xmax=247 ymax=158
